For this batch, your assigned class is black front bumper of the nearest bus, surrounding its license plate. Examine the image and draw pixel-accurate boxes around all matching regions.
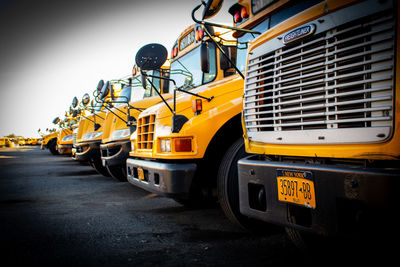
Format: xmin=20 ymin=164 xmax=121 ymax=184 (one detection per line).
xmin=238 ymin=156 xmax=400 ymax=235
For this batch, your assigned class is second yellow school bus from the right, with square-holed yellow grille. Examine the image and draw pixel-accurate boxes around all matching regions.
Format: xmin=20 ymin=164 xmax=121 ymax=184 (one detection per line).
xmin=127 ymin=24 xmax=247 ymax=209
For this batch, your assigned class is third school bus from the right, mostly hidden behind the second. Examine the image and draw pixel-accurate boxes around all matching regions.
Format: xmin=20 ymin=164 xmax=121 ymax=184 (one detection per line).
xmin=100 ymin=66 xmax=171 ymax=181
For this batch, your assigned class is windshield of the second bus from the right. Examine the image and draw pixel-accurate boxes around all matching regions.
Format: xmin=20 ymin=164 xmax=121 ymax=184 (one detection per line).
xmin=171 ymin=43 xmax=217 ymax=90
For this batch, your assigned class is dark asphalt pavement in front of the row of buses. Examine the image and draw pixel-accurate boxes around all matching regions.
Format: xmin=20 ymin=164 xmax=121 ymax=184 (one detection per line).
xmin=0 ymin=147 xmax=394 ymax=266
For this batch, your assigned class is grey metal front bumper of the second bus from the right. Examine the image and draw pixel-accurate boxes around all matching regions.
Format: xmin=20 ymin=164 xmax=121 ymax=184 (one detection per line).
xmin=126 ymin=158 xmax=196 ymax=197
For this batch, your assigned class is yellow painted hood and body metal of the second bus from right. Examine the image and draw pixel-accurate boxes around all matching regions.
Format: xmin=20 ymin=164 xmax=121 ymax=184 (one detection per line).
xmin=130 ymin=26 xmax=243 ymax=159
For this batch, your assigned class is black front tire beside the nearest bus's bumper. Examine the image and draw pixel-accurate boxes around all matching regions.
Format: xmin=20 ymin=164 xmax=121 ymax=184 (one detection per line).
xmin=217 ymin=138 xmax=265 ymax=232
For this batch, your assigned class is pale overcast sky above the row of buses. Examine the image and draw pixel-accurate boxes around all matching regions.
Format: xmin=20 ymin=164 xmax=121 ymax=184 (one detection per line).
xmin=0 ymin=0 xmax=236 ymax=137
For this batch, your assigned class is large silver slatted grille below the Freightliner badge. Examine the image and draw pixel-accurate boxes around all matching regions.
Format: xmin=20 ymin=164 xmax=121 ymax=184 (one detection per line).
xmin=244 ymin=8 xmax=395 ymax=146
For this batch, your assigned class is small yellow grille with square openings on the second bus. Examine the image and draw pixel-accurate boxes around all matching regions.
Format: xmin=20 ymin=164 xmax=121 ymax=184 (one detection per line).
xmin=137 ymin=115 xmax=156 ymax=149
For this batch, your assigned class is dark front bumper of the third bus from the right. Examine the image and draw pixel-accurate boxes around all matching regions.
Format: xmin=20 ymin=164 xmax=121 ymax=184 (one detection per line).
xmin=100 ymin=141 xmax=131 ymax=167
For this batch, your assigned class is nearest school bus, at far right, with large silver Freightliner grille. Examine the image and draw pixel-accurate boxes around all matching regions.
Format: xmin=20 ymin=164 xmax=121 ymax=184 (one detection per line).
xmin=208 ymin=0 xmax=400 ymax=242
